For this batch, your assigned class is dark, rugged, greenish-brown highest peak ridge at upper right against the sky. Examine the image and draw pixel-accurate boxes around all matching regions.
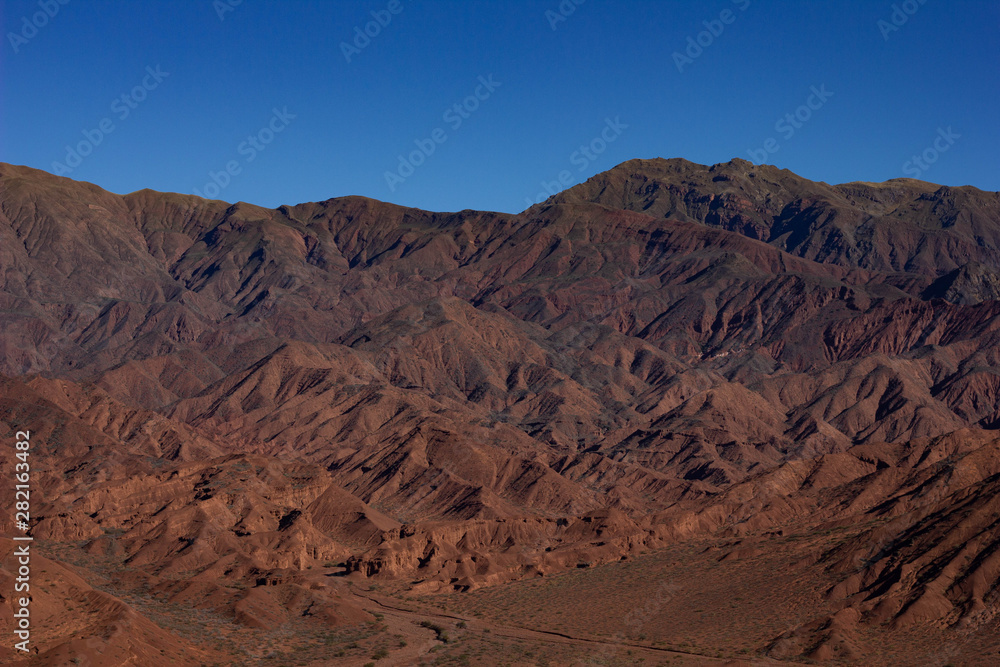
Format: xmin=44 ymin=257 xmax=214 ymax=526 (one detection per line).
xmin=550 ymin=159 xmax=1000 ymax=288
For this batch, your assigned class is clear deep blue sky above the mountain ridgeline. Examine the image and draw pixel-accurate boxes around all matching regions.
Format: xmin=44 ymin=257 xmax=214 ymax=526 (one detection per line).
xmin=0 ymin=0 xmax=1000 ymax=212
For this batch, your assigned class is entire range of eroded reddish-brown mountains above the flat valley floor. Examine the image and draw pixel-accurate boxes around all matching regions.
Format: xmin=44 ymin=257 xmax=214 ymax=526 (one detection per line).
xmin=0 ymin=160 xmax=1000 ymax=664
